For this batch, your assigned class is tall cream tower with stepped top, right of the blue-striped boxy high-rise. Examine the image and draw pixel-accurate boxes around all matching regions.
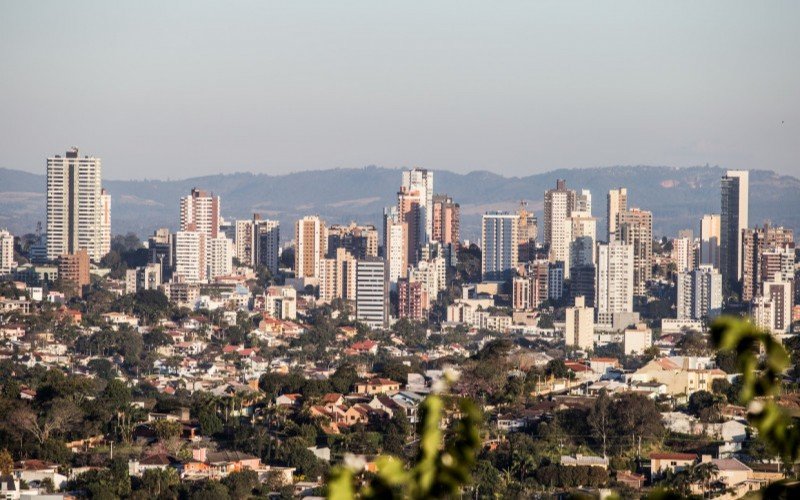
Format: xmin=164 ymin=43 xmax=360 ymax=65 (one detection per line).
xmin=544 ymin=179 xmax=575 ymax=278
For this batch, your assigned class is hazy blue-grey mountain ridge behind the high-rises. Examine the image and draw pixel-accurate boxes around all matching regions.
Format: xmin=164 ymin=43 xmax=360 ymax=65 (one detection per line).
xmin=0 ymin=166 xmax=800 ymax=240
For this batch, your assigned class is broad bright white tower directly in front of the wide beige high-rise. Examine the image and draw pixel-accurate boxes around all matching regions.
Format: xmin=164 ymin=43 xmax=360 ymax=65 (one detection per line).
xmin=595 ymin=240 xmax=634 ymax=324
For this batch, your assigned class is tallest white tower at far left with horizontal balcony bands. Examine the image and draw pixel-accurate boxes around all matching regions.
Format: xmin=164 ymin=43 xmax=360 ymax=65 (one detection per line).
xmin=47 ymin=148 xmax=105 ymax=261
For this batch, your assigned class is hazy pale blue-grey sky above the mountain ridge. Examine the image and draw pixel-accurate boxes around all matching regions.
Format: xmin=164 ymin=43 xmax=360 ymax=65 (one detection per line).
xmin=0 ymin=0 xmax=800 ymax=179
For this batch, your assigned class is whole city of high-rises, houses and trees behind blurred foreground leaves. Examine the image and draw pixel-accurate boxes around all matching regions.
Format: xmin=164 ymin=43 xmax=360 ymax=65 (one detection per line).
xmin=0 ymin=160 xmax=800 ymax=498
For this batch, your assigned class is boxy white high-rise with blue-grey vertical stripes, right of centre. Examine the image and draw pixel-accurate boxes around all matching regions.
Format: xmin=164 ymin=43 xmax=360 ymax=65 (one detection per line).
xmin=481 ymin=212 xmax=519 ymax=281
